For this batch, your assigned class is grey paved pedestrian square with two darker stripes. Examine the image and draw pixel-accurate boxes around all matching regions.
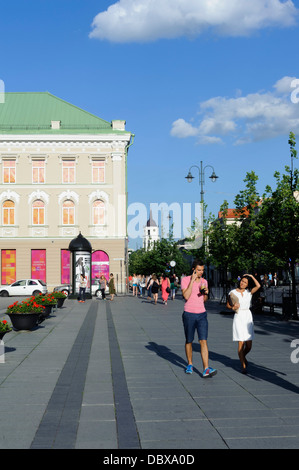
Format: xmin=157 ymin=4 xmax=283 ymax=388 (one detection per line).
xmin=0 ymin=296 xmax=299 ymax=450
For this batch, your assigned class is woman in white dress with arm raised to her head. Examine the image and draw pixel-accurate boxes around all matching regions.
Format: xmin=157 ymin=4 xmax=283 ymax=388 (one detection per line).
xmin=227 ymin=274 xmax=261 ymax=374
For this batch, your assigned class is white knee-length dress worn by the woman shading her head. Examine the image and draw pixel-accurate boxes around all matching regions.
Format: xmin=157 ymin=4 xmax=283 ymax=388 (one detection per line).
xmin=231 ymin=289 xmax=254 ymax=341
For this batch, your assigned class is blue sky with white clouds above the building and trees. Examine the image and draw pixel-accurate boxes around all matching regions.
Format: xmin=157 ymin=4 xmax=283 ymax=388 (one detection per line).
xmin=0 ymin=0 xmax=299 ymax=248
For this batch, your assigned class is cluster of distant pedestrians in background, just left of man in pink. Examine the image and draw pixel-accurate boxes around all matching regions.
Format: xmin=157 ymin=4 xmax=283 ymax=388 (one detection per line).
xmin=132 ymin=273 xmax=178 ymax=305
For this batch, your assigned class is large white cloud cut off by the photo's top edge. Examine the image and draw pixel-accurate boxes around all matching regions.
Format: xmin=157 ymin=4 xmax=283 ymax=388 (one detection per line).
xmin=90 ymin=0 xmax=298 ymax=42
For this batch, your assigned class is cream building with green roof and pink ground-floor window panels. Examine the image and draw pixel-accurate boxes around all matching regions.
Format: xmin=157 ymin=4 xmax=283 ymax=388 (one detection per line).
xmin=0 ymin=93 xmax=134 ymax=292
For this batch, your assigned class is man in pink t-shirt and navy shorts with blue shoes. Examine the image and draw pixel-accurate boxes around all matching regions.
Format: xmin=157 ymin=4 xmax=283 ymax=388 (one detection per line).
xmin=181 ymin=260 xmax=217 ymax=378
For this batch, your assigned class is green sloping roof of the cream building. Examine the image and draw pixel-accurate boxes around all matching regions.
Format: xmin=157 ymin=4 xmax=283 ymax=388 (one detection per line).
xmin=0 ymin=92 xmax=126 ymax=134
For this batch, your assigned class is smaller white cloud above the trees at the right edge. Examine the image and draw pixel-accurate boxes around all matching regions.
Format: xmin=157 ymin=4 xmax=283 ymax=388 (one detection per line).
xmin=171 ymin=77 xmax=299 ymax=144
